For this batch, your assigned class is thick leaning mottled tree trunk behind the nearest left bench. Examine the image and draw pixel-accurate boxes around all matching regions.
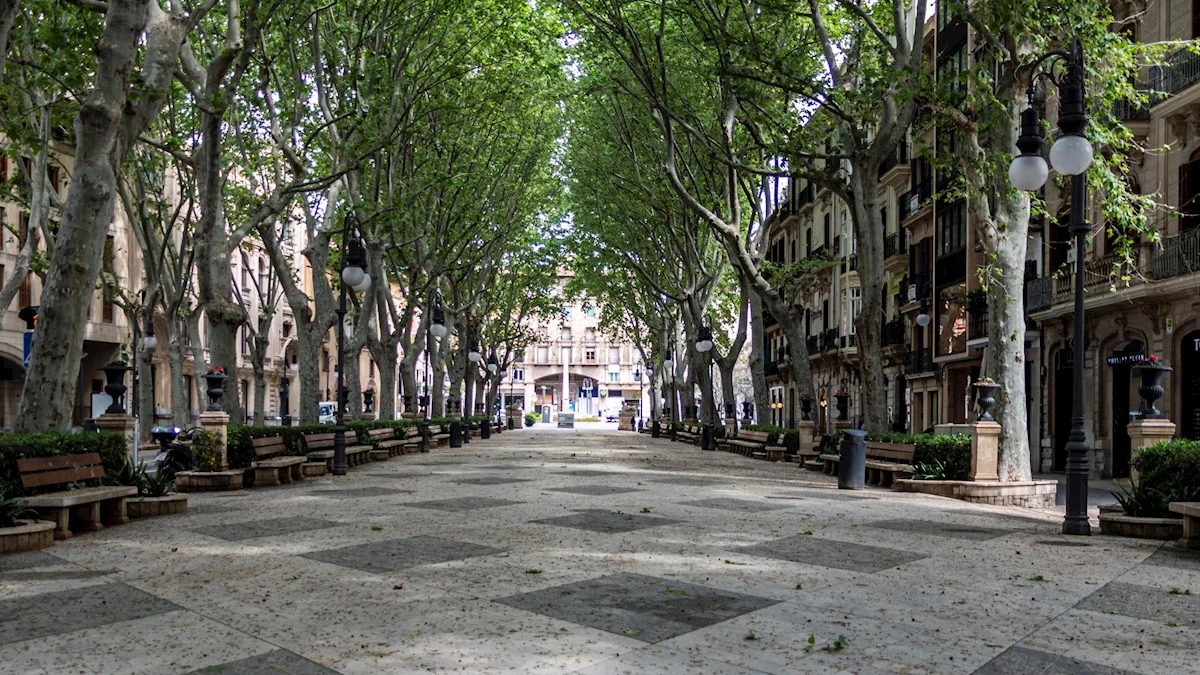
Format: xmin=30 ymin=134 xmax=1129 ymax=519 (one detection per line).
xmin=13 ymin=0 xmax=154 ymax=434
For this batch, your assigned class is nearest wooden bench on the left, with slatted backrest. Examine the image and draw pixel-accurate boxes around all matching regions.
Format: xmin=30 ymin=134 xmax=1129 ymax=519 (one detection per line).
xmin=17 ymin=453 xmax=138 ymax=539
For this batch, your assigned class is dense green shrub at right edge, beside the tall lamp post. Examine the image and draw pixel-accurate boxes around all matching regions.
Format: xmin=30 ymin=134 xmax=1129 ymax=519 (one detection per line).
xmin=1114 ymin=440 xmax=1200 ymax=518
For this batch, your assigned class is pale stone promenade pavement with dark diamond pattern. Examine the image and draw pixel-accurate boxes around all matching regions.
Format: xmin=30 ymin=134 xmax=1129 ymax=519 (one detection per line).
xmin=0 ymin=428 xmax=1200 ymax=675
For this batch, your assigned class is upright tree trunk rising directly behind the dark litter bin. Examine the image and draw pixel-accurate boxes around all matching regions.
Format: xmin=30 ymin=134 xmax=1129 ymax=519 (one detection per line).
xmin=851 ymin=170 xmax=888 ymax=432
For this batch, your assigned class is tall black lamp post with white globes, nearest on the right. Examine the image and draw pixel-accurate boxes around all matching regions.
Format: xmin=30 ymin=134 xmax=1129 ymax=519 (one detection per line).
xmin=1008 ymin=37 xmax=1092 ymax=534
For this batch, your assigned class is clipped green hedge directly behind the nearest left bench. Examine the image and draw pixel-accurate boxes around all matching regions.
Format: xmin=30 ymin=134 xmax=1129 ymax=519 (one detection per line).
xmin=0 ymin=431 xmax=130 ymax=496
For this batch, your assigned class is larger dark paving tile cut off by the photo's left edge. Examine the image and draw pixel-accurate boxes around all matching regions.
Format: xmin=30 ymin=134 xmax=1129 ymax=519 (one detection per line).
xmin=0 ymin=584 xmax=182 ymax=644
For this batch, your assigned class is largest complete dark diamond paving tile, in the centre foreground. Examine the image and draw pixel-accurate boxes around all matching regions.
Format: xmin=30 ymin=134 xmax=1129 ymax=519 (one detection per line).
xmin=496 ymin=574 xmax=779 ymax=643
